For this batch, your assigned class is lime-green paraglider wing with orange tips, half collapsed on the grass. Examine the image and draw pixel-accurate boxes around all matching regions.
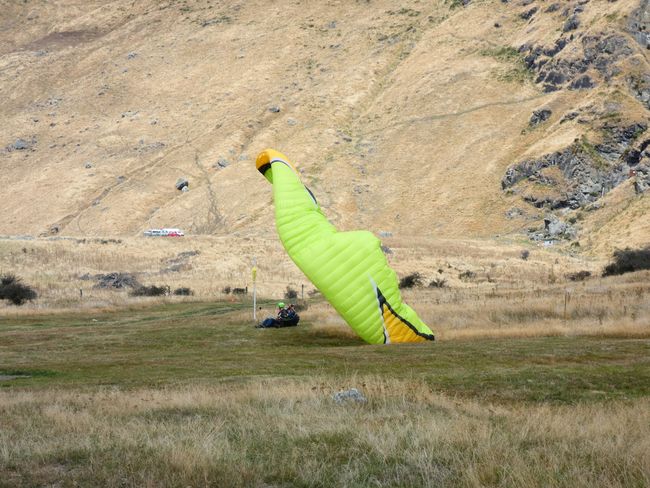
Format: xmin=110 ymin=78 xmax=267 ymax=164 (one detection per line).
xmin=256 ymin=149 xmax=434 ymax=344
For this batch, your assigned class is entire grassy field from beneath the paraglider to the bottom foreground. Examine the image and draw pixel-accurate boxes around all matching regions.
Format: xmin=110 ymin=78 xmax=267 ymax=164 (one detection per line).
xmin=0 ymin=299 xmax=650 ymax=487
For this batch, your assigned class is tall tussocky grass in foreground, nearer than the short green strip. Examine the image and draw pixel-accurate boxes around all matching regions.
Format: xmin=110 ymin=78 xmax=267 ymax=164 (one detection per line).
xmin=0 ymin=384 xmax=650 ymax=487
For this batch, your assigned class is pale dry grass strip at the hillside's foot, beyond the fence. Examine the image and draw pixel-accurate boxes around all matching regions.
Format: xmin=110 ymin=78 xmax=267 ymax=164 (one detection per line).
xmin=0 ymin=236 xmax=605 ymax=306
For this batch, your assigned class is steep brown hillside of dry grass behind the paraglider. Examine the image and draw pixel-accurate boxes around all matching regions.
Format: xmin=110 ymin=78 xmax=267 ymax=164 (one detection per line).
xmin=0 ymin=0 xmax=650 ymax=253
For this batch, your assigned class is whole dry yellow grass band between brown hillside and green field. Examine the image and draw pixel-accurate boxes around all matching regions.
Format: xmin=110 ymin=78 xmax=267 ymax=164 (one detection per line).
xmin=0 ymin=237 xmax=650 ymax=340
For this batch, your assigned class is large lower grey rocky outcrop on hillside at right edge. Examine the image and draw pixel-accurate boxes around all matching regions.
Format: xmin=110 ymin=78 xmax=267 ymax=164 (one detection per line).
xmin=501 ymin=123 xmax=650 ymax=210
